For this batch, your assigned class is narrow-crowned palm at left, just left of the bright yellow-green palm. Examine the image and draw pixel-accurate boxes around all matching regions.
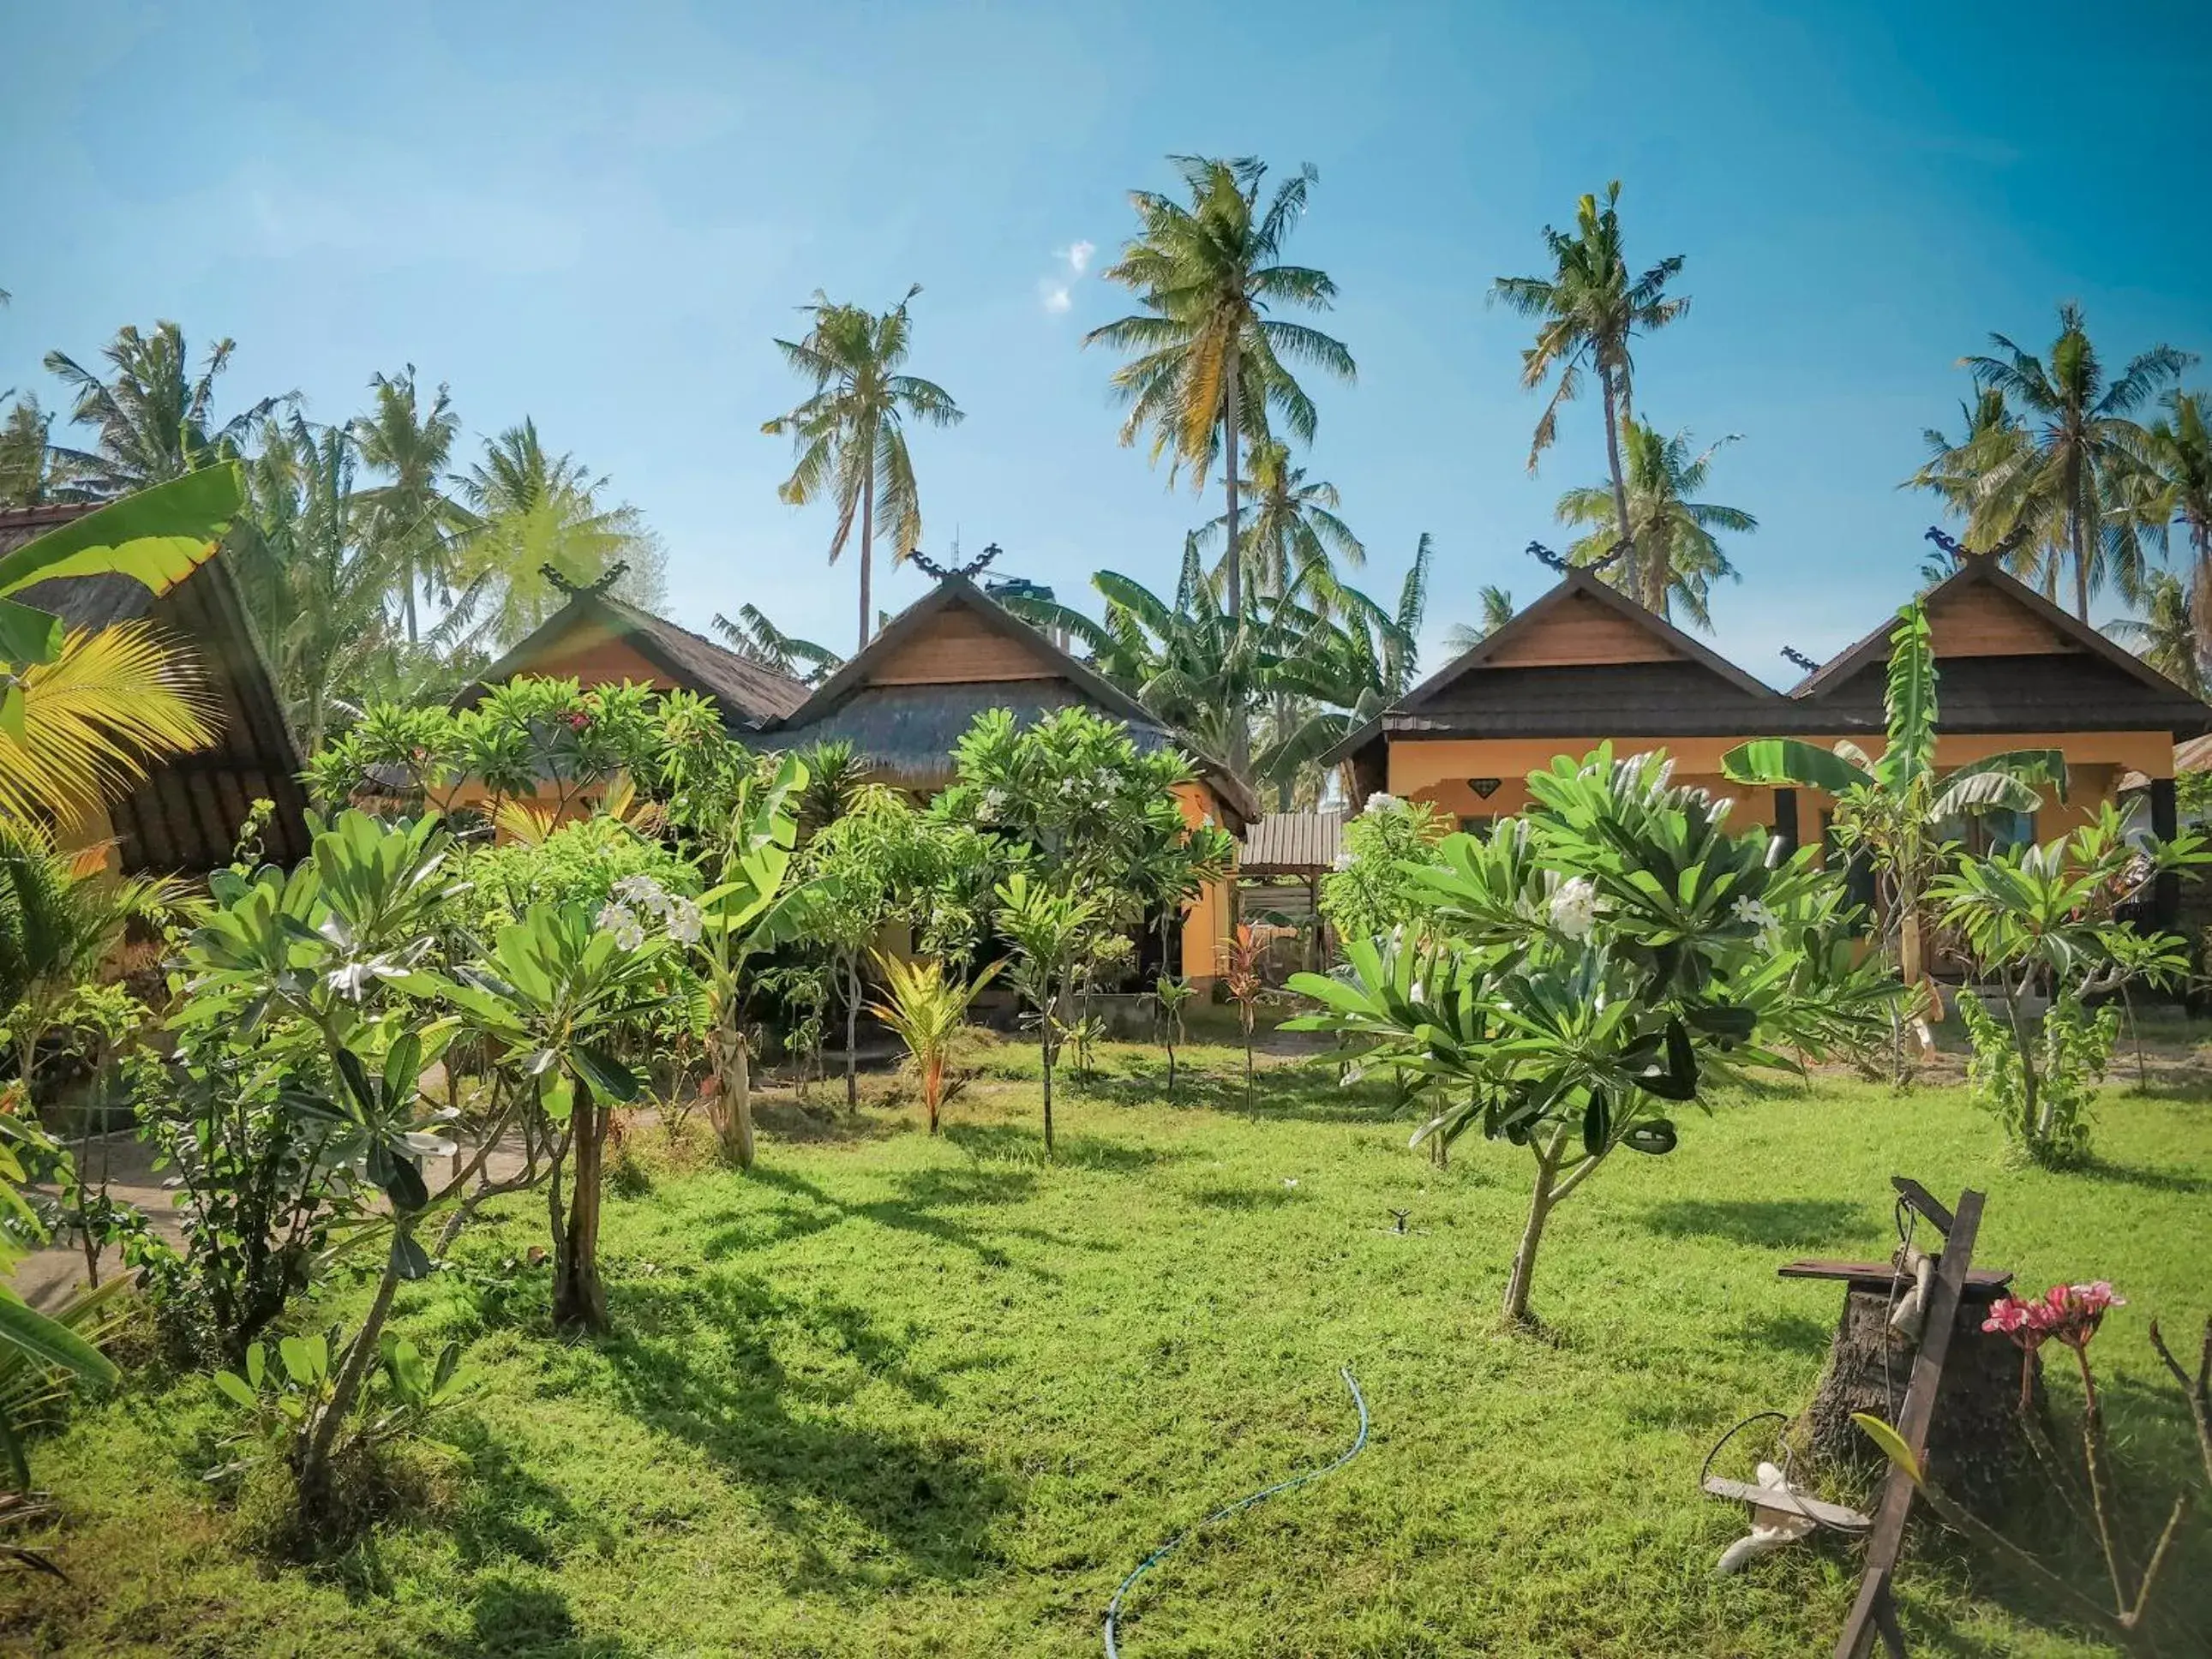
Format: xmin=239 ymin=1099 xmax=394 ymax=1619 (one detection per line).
xmin=351 ymin=362 xmax=476 ymax=646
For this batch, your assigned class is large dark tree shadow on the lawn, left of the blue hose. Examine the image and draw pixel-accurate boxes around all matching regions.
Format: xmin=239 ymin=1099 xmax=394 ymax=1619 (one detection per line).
xmin=604 ymin=1276 xmax=1013 ymax=1595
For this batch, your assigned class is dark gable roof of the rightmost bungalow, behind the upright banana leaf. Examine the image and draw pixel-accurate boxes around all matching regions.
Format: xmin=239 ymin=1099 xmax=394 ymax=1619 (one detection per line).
xmin=1789 ymin=557 xmax=2212 ymax=737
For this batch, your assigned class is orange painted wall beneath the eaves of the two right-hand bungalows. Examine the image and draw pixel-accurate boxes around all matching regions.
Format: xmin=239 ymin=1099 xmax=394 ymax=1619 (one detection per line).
xmin=1387 ymin=732 xmax=2174 ymax=842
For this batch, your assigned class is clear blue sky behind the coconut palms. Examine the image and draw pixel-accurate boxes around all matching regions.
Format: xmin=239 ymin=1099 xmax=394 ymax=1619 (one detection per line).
xmin=0 ymin=0 xmax=2212 ymax=679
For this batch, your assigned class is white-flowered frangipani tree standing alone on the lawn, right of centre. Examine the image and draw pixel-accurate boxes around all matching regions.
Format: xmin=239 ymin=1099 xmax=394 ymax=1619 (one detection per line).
xmin=1290 ymin=750 xmax=1882 ymax=1323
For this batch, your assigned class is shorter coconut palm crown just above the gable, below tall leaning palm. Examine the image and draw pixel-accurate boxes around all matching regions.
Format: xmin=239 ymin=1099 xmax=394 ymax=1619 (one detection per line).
xmin=1557 ymin=420 xmax=1759 ymax=631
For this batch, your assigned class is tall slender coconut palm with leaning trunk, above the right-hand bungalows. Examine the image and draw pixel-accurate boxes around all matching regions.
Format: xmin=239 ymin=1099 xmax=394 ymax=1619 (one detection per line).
xmin=1491 ymin=179 xmax=1690 ymax=595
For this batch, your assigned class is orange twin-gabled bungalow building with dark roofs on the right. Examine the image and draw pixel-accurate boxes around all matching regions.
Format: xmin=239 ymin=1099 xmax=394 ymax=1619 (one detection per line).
xmin=1334 ymin=560 xmax=2212 ymax=937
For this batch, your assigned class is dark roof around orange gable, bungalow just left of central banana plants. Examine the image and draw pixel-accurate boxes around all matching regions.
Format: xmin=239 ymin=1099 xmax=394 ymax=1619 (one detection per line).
xmin=763 ymin=575 xmax=1259 ymax=823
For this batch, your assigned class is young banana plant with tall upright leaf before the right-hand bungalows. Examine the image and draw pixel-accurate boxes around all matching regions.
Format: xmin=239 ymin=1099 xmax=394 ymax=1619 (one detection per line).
xmin=1721 ymin=600 xmax=2066 ymax=1039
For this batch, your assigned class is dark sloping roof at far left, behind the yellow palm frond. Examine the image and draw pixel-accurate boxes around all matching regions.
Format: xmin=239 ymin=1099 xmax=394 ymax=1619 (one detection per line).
xmin=0 ymin=505 xmax=308 ymax=876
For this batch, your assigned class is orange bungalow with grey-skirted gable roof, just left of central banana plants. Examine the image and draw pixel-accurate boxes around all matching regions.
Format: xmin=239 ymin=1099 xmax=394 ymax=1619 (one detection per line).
xmin=763 ymin=575 xmax=1259 ymax=980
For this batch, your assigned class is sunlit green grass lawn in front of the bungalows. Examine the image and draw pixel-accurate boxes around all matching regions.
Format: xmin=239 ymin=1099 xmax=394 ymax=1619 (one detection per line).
xmin=0 ymin=1046 xmax=2212 ymax=1659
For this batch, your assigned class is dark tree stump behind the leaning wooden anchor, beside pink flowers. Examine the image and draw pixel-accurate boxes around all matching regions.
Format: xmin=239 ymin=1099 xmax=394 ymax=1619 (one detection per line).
xmin=1796 ymin=1283 xmax=2044 ymax=1515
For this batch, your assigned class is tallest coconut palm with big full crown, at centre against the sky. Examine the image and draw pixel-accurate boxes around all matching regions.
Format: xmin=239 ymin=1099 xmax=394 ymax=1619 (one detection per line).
xmin=1084 ymin=155 xmax=1358 ymax=774
